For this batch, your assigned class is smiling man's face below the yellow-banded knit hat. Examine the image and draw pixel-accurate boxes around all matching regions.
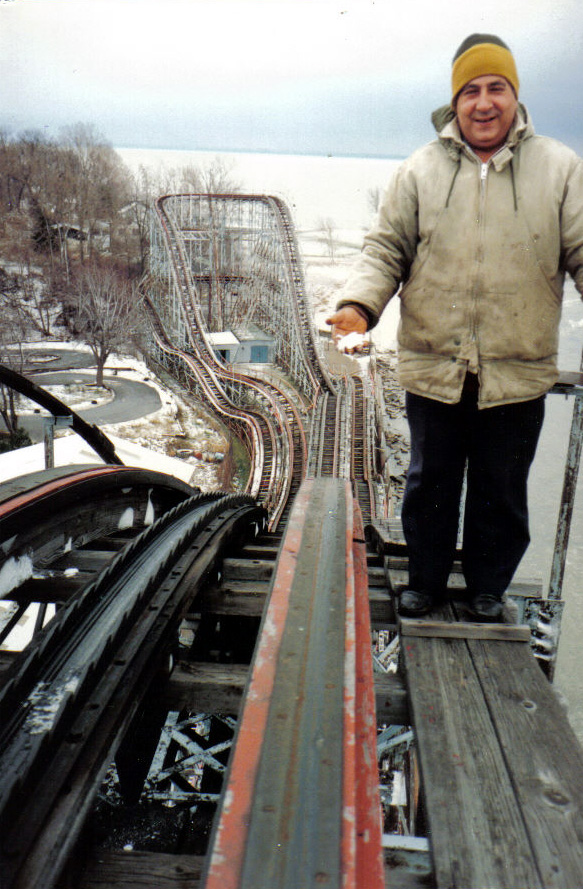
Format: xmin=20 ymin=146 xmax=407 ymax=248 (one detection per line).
xmin=455 ymin=74 xmax=518 ymax=160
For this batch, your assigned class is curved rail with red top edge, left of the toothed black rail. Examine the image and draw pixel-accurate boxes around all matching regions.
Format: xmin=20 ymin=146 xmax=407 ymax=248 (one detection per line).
xmin=0 ymin=464 xmax=196 ymax=645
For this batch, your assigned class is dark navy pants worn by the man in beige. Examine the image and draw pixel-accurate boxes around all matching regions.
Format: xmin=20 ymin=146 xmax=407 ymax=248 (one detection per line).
xmin=402 ymin=376 xmax=545 ymax=597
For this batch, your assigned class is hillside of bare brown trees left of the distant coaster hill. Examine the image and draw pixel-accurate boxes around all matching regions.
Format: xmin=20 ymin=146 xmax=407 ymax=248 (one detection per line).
xmin=0 ymin=124 xmax=239 ymax=443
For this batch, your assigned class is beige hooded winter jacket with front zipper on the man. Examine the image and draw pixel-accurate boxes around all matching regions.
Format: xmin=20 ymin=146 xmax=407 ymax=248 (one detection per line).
xmin=338 ymin=106 xmax=583 ymax=407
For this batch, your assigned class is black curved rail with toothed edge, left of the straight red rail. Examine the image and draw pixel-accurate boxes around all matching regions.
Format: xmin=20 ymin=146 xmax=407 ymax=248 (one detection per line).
xmin=0 ymin=486 xmax=265 ymax=889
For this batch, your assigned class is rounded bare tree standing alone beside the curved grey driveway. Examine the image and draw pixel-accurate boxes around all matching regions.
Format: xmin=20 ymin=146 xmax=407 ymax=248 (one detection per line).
xmin=73 ymin=264 xmax=144 ymax=386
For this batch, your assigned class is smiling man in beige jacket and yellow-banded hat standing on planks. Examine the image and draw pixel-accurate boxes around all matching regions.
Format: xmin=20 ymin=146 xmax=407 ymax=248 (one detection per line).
xmin=328 ymin=34 xmax=583 ymax=621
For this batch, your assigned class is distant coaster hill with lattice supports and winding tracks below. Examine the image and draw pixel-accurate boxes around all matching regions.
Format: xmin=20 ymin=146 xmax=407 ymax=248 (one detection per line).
xmin=150 ymin=195 xmax=387 ymax=530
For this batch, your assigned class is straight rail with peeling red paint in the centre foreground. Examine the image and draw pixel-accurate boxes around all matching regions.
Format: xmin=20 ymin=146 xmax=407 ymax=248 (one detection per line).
xmin=205 ymin=478 xmax=384 ymax=889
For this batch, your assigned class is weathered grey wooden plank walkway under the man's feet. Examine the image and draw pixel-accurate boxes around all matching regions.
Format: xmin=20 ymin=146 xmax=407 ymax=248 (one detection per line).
xmin=389 ymin=520 xmax=583 ymax=889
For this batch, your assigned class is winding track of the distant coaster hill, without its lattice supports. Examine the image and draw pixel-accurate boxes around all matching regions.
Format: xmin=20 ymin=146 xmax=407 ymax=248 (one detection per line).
xmin=149 ymin=195 xmax=384 ymax=512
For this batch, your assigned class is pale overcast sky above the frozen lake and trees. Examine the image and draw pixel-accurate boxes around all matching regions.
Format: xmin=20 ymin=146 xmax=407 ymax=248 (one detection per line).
xmin=0 ymin=0 xmax=583 ymax=157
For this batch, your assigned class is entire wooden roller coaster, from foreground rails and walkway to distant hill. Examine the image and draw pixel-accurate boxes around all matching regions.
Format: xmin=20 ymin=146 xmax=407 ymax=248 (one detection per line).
xmin=0 ymin=195 xmax=583 ymax=889
